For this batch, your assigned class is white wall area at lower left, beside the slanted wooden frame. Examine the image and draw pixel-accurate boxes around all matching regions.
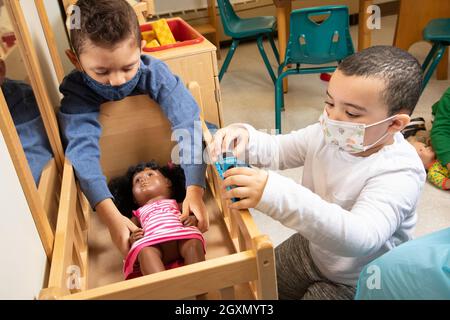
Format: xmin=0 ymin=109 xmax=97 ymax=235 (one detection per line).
xmin=0 ymin=132 xmax=47 ymax=300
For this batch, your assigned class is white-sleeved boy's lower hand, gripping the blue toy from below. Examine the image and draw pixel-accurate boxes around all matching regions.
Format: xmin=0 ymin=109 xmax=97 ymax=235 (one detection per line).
xmin=223 ymin=167 xmax=269 ymax=209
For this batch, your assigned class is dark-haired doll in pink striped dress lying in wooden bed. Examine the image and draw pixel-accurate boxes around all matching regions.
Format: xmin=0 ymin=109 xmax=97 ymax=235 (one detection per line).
xmin=108 ymin=161 xmax=205 ymax=279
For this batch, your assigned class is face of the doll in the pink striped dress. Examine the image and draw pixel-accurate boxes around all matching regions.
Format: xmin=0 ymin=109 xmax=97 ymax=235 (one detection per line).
xmin=132 ymin=168 xmax=172 ymax=207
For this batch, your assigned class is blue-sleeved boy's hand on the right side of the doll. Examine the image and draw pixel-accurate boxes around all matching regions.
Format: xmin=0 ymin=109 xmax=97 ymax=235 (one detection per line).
xmin=180 ymin=185 xmax=209 ymax=232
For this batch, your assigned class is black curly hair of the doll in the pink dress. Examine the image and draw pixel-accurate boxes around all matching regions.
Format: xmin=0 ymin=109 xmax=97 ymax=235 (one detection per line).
xmin=108 ymin=161 xmax=186 ymax=218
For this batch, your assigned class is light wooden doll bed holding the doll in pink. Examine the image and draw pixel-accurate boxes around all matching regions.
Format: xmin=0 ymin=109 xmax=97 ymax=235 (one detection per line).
xmin=40 ymin=83 xmax=277 ymax=300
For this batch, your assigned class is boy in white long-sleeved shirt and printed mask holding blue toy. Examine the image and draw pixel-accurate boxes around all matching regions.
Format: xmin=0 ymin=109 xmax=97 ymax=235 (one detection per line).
xmin=213 ymin=46 xmax=425 ymax=299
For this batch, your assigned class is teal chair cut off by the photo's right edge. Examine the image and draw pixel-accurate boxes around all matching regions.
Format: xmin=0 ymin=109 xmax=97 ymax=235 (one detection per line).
xmin=422 ymin=19 xmax=450 ymax=91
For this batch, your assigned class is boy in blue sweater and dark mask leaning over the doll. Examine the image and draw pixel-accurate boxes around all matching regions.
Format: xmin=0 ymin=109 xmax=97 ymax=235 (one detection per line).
xmin=58 ymin=0 xmax=208 ymax=256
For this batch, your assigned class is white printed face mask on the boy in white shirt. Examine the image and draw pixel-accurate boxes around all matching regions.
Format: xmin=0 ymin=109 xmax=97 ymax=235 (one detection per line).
xmin=319 ymin=110 xmax=395 ymax=153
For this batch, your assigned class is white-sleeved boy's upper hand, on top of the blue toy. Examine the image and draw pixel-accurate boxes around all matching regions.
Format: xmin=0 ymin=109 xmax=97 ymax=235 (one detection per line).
xmin=210 ymin=125 xmax=249 ymax=161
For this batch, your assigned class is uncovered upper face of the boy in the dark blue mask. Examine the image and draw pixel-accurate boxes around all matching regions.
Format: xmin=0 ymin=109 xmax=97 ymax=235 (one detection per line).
xmin=79 ymin=37 xmax=145 ymax=86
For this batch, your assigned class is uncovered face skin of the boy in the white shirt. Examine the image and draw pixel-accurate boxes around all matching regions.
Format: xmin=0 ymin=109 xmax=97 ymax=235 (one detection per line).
xmin=325 ymin=70 xmax=398 ymax=149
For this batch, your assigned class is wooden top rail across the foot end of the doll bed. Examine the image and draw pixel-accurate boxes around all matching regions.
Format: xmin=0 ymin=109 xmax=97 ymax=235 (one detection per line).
xmin=63 ymin=251 xmax=257 ymax=300
